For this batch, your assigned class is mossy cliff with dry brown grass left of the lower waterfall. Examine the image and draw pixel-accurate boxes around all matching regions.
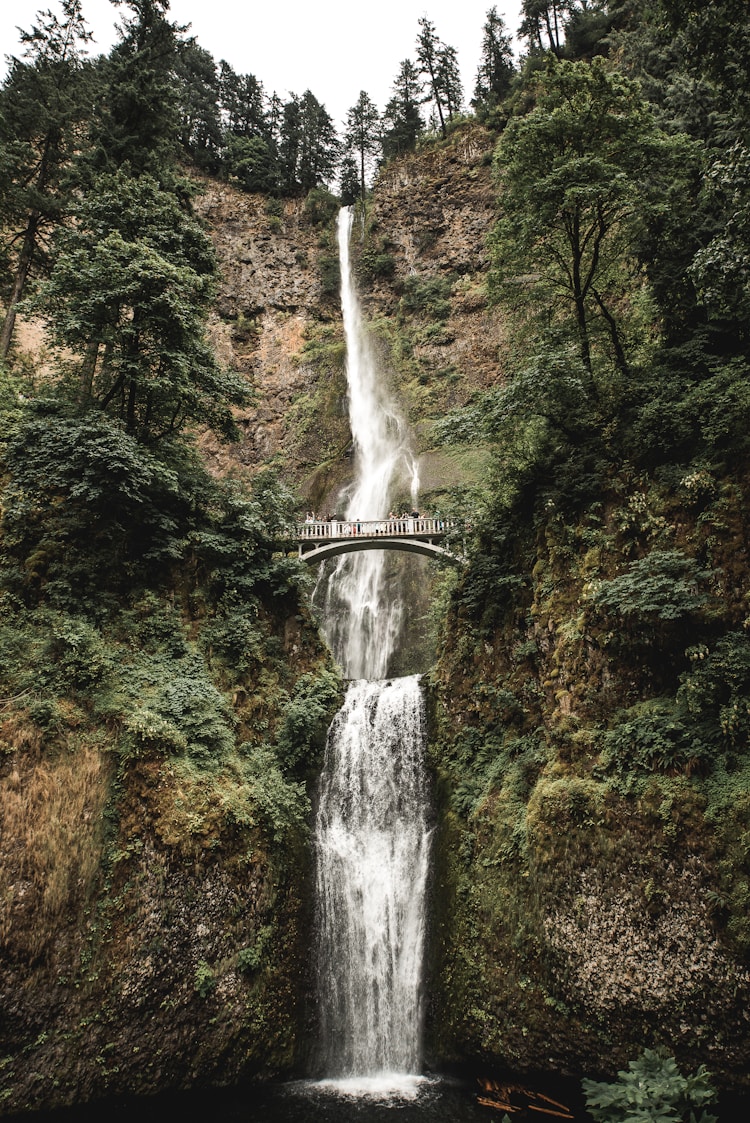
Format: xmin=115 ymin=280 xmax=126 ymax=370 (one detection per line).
xmin=0 ymin=559 xmax=338 ymax=1112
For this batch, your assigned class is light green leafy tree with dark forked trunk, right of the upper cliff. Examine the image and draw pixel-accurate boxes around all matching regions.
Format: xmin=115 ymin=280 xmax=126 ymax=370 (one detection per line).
xmin=491 ymin=58 xmax=692 ymax=373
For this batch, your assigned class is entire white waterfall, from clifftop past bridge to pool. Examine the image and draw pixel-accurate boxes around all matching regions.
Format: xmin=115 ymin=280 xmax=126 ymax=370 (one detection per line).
xmin=315 ymin=208 xmax=430 ymax=1087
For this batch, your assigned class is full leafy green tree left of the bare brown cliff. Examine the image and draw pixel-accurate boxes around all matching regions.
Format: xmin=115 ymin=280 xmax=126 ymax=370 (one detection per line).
xmin=37 ymin=171 xmax=244 ymax=444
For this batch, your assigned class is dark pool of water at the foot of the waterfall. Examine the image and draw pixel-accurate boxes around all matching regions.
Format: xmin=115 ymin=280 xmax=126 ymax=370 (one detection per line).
xmin=8 ymin=1076 xmax=750 ymax=1123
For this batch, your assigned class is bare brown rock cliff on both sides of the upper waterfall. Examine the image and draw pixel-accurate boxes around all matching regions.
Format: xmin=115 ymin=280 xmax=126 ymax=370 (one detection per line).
xmin=190 ymin=127 xmax=502 ymax=510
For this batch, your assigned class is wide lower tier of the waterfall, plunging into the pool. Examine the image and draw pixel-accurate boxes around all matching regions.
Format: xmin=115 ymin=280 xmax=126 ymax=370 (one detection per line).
xmin=315 ymin=676 xmax=430 ymax=1077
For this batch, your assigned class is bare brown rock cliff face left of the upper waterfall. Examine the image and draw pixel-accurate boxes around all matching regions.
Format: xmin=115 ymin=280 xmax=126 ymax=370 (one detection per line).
xmin=190 ymin=182 xmax=349 ymax=499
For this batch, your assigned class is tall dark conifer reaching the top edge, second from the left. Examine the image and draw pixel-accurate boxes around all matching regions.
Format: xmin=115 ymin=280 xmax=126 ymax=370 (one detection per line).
xmin=86 ymin=0 xmax=185 ymax=179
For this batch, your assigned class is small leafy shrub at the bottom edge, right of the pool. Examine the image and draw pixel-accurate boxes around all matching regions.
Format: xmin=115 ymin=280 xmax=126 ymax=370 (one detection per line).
xmin=582 ymin=1049 xmax=717 ymax=1123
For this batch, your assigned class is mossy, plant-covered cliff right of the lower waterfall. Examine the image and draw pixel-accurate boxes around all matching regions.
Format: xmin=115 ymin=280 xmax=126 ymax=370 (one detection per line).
xmin=428 ymin=465 xmax=750 ymax=1086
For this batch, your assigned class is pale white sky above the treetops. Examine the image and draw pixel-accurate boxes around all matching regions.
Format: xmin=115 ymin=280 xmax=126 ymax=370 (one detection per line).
xmin=0 ymin=0 xmax=521 ymax=127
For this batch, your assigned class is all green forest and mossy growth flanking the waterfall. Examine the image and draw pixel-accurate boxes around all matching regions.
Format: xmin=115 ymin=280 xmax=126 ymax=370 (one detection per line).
xmin=0 ymin=0 xmax=750 ymax=1119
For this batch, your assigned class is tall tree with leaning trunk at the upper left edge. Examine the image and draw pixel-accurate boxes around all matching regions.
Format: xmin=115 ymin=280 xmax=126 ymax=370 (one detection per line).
xmin=0 ymin=0 xmax=91 ymax=359
